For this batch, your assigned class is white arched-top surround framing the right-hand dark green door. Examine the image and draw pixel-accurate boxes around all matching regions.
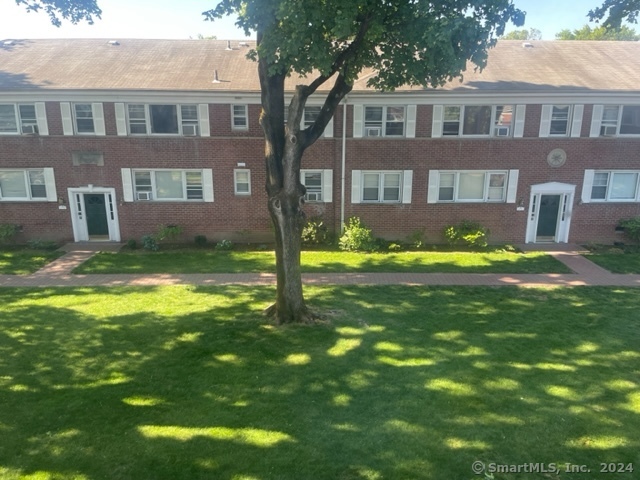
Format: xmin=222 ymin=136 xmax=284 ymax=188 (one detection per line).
xmin=525 ymin=182 xmax=576 ymax=243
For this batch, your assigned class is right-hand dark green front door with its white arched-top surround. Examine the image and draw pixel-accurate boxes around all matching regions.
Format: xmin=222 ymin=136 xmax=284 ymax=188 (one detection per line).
xmin=526 ymin=182 xmax=576 ymax=243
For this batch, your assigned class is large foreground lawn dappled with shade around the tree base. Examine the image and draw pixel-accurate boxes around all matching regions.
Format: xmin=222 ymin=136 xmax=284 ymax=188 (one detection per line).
xmin=0 ymin=286 xmax=640 ymax=480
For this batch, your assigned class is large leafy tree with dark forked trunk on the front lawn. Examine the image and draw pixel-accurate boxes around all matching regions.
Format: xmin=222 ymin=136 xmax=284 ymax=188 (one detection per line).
xmin=18 ymin=0 xmax=524 ymax=324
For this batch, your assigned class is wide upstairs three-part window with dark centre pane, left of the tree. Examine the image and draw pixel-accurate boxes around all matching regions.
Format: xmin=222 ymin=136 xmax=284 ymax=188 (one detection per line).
xmin=127 ymin=104 xmax=198 ymax=136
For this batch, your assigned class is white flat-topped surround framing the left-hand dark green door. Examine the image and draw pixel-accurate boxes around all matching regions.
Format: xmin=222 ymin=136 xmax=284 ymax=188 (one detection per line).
xmin=67 ymin=185 xmax=120 ymax=242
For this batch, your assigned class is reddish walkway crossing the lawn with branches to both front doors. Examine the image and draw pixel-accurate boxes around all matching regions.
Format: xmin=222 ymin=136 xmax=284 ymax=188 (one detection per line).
xmin=0 ymin=244 xmax=640 ymax=287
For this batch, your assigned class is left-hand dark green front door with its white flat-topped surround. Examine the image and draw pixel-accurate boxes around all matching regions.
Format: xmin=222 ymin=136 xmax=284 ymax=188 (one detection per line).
xmin=68 ymin=185 xmax=120 ymax=242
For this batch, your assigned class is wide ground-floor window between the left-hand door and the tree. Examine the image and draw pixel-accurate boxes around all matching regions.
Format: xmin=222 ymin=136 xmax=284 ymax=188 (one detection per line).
xmin=133 ymin=170 xmax=203 ymax=201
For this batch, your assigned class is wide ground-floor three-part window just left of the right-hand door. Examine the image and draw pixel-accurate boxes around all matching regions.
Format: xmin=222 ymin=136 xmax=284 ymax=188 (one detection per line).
xmin=438 ymin=170 xmax=507 ymax=202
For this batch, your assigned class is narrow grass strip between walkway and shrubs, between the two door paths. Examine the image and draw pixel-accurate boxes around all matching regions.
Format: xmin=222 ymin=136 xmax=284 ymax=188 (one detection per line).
xmin=74 ymin=250 xmax=570 ymax=273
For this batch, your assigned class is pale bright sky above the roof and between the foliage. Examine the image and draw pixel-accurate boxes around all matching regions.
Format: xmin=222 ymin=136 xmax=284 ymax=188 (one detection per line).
xmin=0 ymin=0 xmax=628 ymax=40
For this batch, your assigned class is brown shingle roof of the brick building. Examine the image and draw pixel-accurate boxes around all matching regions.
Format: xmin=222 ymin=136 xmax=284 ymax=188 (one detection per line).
xmin=0 ymin=39 xmax=640 ymax=92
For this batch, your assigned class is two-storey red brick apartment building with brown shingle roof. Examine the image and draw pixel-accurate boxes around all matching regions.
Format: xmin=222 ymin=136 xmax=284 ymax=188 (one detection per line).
xmin=0 ymin=39 xmax=640 ymax=243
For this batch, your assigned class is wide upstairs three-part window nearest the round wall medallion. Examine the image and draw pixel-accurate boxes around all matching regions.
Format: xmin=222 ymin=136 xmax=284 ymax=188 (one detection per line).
xmin=442 ymin=105 xmax=513 ymax=137
